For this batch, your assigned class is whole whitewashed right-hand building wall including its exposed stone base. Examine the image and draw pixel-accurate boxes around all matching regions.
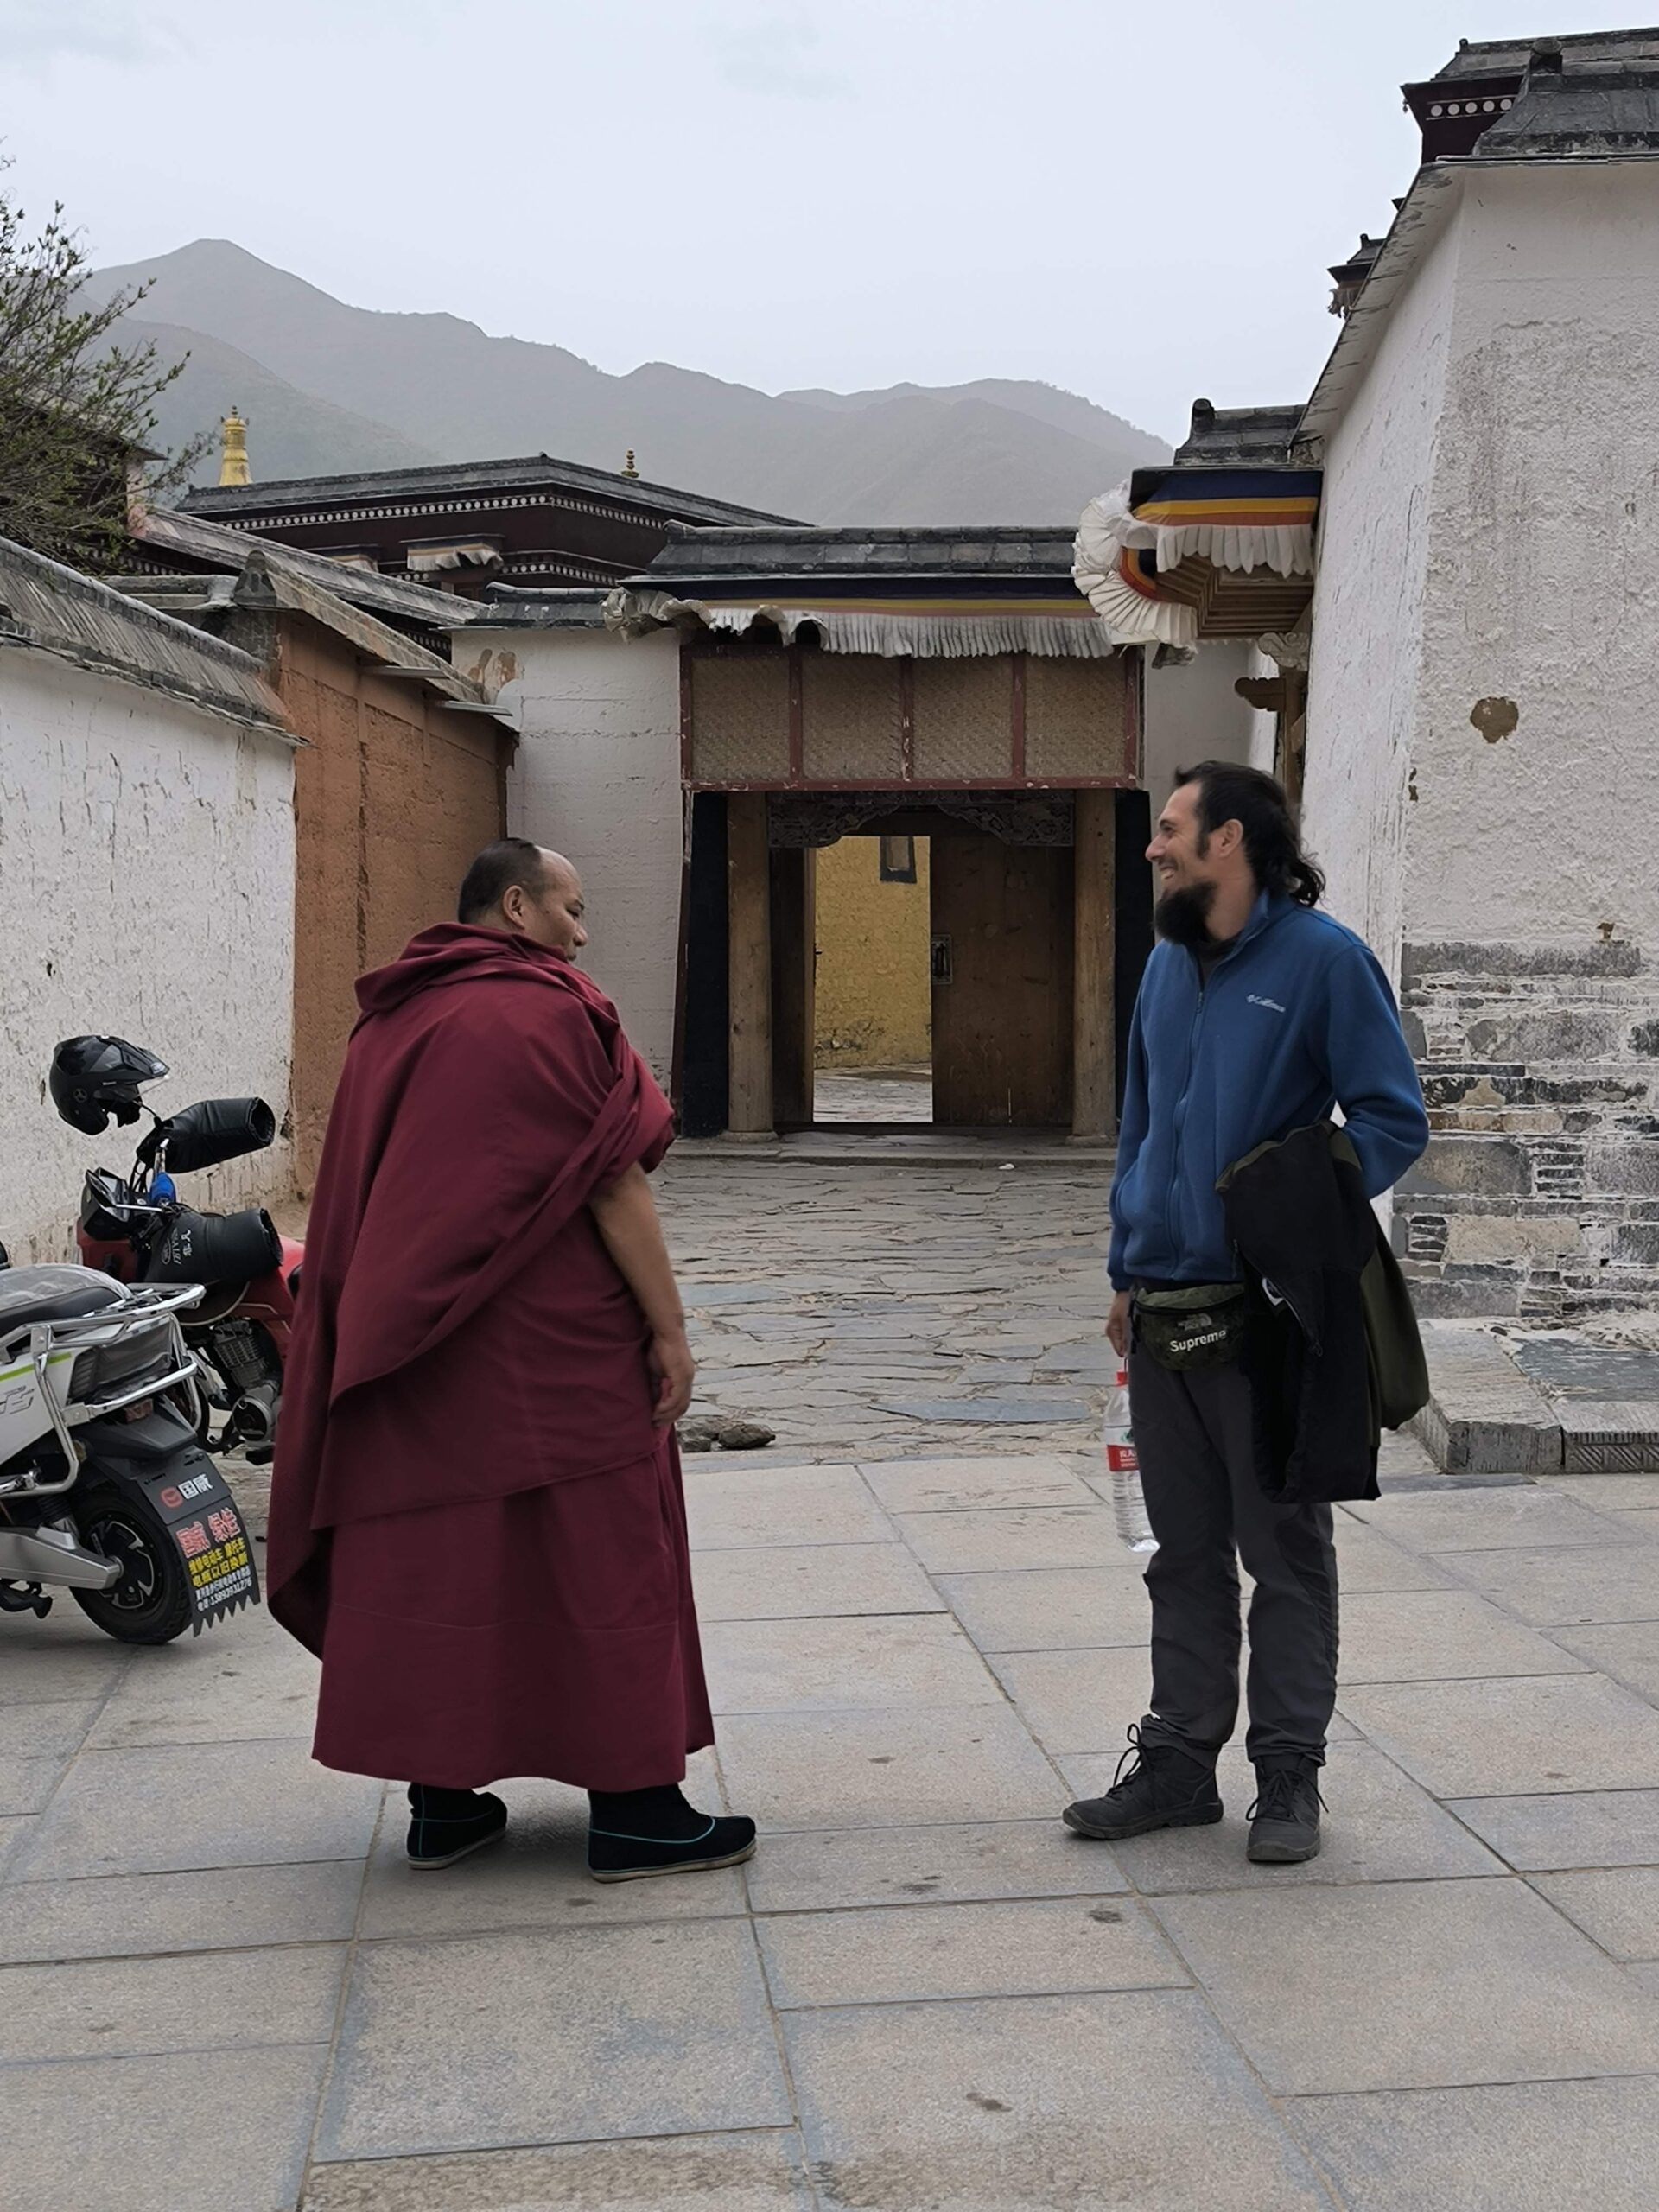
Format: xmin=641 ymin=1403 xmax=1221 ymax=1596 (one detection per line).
xmin=1310 ymin=162 xmax=1659 ymax=1319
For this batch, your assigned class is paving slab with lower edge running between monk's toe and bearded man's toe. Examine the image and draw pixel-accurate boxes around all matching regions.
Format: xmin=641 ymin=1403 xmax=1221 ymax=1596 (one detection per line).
xmin=721 ymin=1706 xmax=1058 ymax=1834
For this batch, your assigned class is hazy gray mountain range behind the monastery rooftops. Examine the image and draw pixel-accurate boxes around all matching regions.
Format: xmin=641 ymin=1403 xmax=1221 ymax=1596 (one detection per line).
xmin=91 ymin=238 xmax=1170 ymax=522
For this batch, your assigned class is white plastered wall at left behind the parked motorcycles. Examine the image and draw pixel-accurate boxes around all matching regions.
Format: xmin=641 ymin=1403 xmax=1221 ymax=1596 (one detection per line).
xmin=0 ymin=648 xmax=294 ymax=1263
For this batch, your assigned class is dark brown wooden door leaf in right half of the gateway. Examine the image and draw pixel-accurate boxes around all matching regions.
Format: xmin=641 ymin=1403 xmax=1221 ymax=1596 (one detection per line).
xmin=931 ymin=830 xmax=1073 ymax=1128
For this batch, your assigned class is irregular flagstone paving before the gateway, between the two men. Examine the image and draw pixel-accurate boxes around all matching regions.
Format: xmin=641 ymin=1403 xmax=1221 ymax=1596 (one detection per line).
xmin=657 ymin=1133 xmax=1113 ymax=1460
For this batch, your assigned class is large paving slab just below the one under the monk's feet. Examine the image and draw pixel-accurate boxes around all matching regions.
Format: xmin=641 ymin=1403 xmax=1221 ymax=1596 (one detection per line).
xmin=319 ymin=1920 xmax=794 ymax=2159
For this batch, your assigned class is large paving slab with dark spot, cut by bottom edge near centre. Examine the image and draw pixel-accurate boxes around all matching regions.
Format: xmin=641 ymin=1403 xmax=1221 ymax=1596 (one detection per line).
xmin=783 ymin=1991 xmax=1330 ymax=2212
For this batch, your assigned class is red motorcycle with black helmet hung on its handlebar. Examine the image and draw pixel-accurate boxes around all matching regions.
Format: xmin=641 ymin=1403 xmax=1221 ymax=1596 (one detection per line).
xmin=48 ymin=1038 xmax=305 ymax=1465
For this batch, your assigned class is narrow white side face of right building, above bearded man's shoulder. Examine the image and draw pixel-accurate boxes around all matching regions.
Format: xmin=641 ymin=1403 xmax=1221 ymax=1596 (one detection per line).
xmin=1303 ymin=211 xmax=1460 ymax=973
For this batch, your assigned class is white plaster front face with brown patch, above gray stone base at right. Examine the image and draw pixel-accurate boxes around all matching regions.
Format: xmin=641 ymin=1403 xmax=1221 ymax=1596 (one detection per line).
xmin=1407 ymin=162 xmax=1659 ymax=944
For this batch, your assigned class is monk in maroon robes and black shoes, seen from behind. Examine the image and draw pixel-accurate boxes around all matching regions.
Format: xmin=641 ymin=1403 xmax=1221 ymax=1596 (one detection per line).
xmin=268 ymin=838 xmax=754 ymax=1883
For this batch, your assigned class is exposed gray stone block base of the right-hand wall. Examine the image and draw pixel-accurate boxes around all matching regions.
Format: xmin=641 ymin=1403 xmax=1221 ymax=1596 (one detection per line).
xmin=1394 ymin=940 xmax=1659 ymax=1320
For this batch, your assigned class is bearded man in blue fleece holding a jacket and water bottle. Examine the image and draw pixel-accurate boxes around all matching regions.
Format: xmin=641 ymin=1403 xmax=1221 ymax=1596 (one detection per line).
xmin=1064 ymin=761 xmax=1429 ymax=1865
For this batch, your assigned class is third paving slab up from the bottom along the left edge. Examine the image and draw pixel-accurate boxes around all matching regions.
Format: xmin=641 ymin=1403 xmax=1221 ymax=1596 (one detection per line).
xmin=0 ymin=1858 xmax=363 ymax=1964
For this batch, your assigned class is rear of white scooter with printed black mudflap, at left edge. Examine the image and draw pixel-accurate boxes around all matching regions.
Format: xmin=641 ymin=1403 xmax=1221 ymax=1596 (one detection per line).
xmin=0 ymin=1248 xmax=259 ymax=1643
